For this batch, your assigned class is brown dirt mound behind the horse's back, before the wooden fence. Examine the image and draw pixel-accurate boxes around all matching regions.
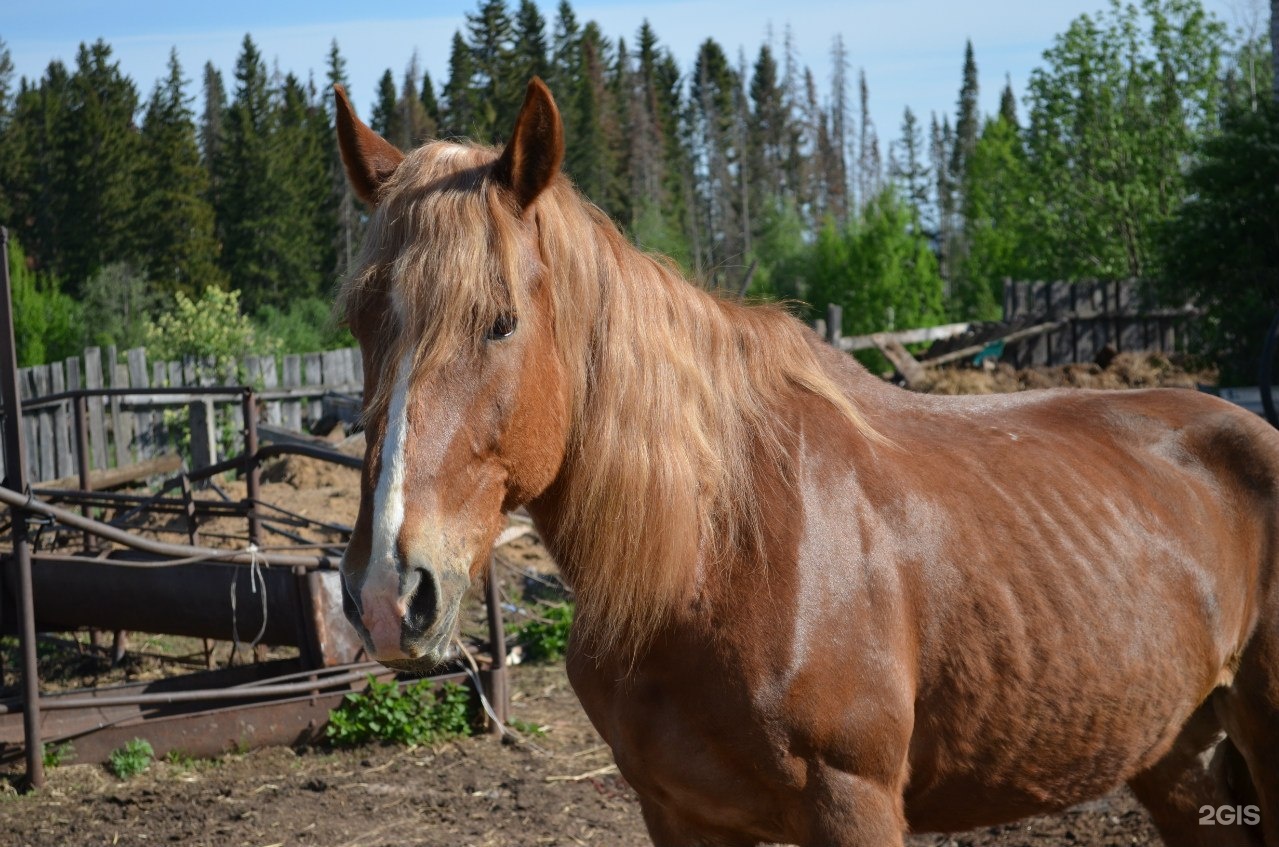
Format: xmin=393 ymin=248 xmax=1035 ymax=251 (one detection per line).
xmin=917 ymin=353 xmax=1216 ymax=394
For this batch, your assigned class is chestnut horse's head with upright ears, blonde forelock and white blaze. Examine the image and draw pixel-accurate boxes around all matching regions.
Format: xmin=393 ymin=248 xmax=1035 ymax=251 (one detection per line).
xmin=338 ymin=79 xmax=569 ymax=670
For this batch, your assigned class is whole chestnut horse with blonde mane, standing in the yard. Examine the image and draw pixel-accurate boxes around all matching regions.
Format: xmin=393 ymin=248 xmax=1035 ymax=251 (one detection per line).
xmin=338 ymin=79 xmax=1279 ymax=847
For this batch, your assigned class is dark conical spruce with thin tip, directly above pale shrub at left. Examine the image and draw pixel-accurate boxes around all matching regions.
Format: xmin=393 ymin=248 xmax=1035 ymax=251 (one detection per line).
xmin=138 ymin=50 xmax=226 ymax=294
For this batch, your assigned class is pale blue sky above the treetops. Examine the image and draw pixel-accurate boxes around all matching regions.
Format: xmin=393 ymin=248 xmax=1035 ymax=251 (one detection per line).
xmin=0 ymin=0 xmax=1269 ymax=147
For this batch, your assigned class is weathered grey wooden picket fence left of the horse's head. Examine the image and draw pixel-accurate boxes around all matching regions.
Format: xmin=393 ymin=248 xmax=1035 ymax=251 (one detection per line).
xmin=0 ymin=347 xmax=363 ymax=482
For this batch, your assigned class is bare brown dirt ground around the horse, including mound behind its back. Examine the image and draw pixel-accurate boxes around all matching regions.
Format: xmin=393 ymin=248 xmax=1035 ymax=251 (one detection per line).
xmin=0 ymin=360 xmax=1200 ymax=847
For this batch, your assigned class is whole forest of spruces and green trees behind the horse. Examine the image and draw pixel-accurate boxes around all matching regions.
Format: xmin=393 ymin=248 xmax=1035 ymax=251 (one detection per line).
xmin=0 ymin=0 xmax=1279 ymax=375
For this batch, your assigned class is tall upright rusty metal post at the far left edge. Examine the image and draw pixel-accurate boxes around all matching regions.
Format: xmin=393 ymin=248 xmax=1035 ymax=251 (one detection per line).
xmin=0 ymin=226 xmax=45 ymax=788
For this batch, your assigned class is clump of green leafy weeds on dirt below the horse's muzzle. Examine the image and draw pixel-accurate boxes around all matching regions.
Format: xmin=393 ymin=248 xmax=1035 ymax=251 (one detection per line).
xmin=325 ymin=676 xmax=471 ymax=747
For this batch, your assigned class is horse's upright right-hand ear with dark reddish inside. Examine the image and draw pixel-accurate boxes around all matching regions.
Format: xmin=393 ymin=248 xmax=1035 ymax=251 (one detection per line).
xmin=494 ymin=77 xmax=564 ymax=209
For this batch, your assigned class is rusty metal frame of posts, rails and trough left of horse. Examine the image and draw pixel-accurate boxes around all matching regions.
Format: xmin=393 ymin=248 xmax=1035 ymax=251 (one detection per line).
xmin=0 ymin=226 xmax=508 ymax=788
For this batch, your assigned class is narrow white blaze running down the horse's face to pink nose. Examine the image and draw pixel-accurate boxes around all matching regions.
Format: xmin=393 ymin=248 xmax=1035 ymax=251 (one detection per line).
xmin=359 ymin=352 xmax=413 ymax=659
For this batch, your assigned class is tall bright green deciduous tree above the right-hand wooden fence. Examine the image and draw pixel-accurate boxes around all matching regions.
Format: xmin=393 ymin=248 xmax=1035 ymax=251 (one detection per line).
xmin=1027 ymin=0 xmax=1225 ymax=279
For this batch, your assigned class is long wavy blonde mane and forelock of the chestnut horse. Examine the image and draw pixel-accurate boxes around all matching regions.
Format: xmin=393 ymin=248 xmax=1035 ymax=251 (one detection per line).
xmin=339 ymin=142 xmax=876 ymax=656
